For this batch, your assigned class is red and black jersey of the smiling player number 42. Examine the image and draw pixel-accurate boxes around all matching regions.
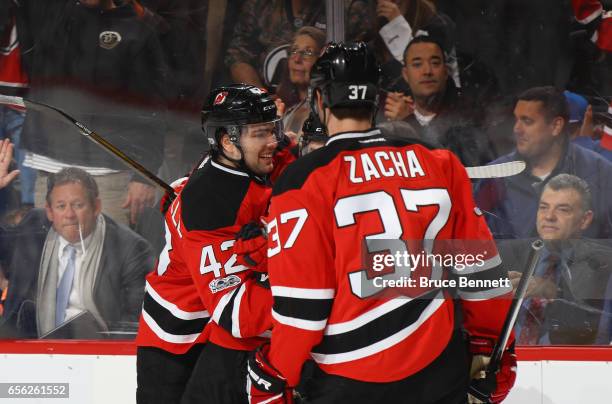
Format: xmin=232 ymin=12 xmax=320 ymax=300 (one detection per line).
xmin=137 ymin=148 xmax=294 ymax=353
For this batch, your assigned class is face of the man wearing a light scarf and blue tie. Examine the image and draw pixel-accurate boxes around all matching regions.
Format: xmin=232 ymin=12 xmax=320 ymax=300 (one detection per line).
xmin=45 ymin=182 xmax=101 ymax=243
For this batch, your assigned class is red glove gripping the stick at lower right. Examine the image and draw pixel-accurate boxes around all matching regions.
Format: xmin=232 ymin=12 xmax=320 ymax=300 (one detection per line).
xmin=468 ymin=337 xmax=516 ymax=403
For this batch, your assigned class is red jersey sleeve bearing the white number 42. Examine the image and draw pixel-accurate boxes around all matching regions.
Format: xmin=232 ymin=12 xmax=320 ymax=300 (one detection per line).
xmin=178 ymin=226 xmax=272 ymax=338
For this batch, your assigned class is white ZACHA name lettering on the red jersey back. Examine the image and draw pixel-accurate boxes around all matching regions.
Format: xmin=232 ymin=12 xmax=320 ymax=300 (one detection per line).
xmin=343 ymin=150 xmax=425 ymax=184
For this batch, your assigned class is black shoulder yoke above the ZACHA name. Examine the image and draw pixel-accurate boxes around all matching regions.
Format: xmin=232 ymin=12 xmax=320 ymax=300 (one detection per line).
xmin=272 ymin=129 xmax=436 ymax=196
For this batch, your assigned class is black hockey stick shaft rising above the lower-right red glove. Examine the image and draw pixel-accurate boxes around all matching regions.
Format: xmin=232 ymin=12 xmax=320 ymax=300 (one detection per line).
xmin=486 ymin=240 xmax=544 ymax=374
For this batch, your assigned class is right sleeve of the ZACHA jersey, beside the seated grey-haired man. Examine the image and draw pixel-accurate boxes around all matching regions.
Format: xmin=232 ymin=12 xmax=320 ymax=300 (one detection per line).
xmin=449 ymin=154 xmax=512 ymax=339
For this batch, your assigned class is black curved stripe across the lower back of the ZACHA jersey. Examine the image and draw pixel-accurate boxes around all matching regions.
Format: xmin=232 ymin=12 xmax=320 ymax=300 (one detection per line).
xmin=312 ymin=290 xmax=439 ymax=355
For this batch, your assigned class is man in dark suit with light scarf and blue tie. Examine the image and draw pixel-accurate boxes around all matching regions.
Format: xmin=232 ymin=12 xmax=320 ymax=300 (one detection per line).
xmin=2 ymin=168 xmax=154 ymax=338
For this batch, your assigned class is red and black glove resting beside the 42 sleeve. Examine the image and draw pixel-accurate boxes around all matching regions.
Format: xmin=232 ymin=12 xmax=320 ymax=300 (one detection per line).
xmin=234 ymin=222 xmax=268 ymax=272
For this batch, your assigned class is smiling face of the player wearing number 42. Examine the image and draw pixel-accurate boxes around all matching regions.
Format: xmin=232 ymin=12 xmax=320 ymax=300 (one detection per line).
xmin=240 ymin=122 xmax=278 ymax=175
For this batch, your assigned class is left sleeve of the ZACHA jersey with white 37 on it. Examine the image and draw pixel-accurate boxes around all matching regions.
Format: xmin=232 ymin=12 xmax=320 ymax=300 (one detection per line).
xmin=268 ymin=191 xmax=336 ymax=386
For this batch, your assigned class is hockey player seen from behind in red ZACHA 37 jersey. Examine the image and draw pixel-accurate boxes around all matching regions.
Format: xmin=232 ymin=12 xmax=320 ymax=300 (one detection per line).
xmin=247 ymin=43 xmax=516 ymax=404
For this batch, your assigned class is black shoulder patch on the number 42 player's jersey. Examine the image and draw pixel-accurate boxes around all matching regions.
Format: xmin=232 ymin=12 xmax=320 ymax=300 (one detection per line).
xmin=181 ymin=160 xmax=251 ymax=231
